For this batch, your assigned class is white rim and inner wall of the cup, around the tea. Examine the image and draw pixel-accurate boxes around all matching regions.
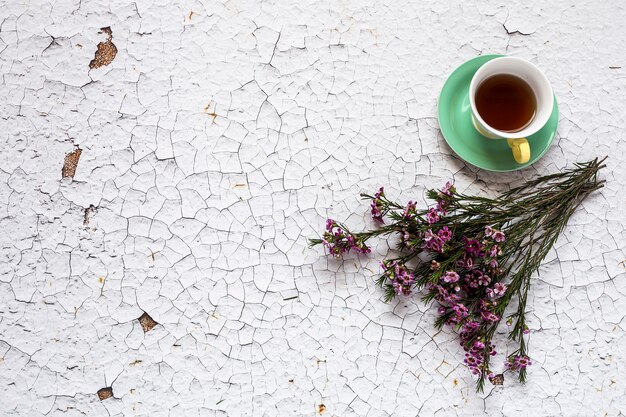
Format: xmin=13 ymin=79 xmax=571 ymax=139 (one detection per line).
xmin=469 ymin=56 xmax=554 ymax=139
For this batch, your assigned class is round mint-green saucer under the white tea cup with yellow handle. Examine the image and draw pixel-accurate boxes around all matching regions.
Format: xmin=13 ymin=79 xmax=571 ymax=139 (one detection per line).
xmin=437 ymin=55 xmax=559 ymax=172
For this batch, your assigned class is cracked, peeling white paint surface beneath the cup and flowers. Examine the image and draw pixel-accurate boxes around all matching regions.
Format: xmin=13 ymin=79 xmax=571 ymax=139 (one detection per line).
xmin=0 ymin=0 xmax=626 ymax=417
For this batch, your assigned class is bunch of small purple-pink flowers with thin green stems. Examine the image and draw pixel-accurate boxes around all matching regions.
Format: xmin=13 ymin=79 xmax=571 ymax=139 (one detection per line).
xmin=310 ymin=158 xmax=604 ymax=392
